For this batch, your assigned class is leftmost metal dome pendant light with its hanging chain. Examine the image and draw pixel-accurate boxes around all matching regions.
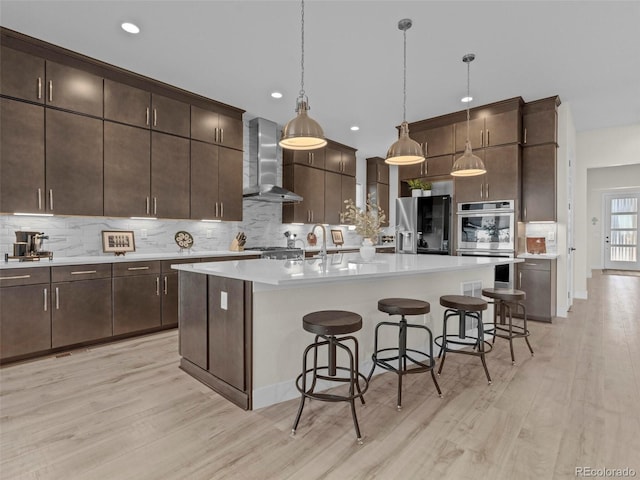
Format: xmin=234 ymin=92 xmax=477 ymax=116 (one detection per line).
xmin=280 ymin=0 xmax=327 ymax=150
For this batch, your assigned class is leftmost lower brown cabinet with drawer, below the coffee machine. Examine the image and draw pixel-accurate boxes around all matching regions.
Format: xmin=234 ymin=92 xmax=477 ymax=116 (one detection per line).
xmin=0 ymin=268 xmax=51 ymax=359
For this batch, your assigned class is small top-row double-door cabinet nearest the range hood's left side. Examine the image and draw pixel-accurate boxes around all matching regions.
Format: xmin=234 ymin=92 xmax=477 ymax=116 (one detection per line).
xmin=191 ymin=105 xmax=243 ymax=150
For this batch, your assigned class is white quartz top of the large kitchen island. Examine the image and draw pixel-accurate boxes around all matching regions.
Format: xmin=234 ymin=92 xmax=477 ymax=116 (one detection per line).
xmin=172 ymin=253 xmax=523 ymax=286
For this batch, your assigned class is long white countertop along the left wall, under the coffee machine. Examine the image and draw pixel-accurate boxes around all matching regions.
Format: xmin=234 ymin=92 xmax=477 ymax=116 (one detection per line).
xmin=0 ymin=250 xmax=261 ymax=270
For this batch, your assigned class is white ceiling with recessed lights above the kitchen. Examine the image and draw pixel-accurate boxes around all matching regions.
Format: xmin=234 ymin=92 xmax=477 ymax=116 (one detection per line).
xmin=0 ymin=0 xmax=640 ymax=157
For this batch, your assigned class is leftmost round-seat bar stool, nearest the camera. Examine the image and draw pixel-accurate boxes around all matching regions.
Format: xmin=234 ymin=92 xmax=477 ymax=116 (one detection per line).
xmin=291 ymin=310 xmax=369 ymax=445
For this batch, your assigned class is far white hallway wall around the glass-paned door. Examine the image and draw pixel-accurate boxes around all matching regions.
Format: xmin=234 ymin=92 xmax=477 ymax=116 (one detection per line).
xmin=587 ymin=161 xmax=640 ymax=270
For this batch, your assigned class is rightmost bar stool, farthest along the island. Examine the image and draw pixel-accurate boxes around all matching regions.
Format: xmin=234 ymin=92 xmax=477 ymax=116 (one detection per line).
xmin=482 ymin=288 xmax=534 ymax=365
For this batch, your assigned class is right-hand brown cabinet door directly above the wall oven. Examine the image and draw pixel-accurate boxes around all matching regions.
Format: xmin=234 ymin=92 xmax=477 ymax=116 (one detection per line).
xmin=483 ymin=145 xmax=520 ymax=200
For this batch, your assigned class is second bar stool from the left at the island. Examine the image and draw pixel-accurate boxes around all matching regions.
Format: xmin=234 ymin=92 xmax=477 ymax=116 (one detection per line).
xmin=367 ymin=298 xmax=442 ymax=410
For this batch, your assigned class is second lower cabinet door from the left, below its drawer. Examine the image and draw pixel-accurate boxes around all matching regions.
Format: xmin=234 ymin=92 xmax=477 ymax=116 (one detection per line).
xmin=51 ymin=278 xmax=112 ymax=348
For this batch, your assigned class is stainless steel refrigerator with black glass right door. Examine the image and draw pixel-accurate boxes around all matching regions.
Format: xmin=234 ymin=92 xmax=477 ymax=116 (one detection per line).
xmin=396 ymin=195 xmax=452 ymax=255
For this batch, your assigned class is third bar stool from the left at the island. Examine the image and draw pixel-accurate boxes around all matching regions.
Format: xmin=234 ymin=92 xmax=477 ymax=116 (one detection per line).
xmin=435 ymin=295 xmax=493 ymax=385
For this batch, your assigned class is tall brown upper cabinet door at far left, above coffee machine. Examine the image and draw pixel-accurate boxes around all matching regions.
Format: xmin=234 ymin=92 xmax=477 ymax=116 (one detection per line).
xmin=0 ymin=98 xmax=45 ymax=213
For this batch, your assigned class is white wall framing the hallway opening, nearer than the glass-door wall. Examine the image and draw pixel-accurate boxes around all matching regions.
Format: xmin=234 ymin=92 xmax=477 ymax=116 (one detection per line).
xmin=574 ymin=123 xmax=640 ymax=298
